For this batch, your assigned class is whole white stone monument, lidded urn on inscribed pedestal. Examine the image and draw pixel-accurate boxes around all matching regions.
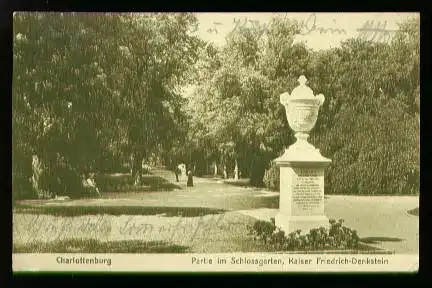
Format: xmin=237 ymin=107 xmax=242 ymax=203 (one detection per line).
xmin=274 ymin=76 xmax=331 ymax=233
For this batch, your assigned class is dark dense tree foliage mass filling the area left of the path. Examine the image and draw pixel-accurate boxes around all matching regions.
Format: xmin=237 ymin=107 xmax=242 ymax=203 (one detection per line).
xmin=12 ymin=13 xmax=201 ymax=197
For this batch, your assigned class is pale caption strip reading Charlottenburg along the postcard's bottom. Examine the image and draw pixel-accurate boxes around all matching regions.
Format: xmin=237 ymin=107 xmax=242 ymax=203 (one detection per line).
xmin=12 ymin=253 xmax=419 ymax=272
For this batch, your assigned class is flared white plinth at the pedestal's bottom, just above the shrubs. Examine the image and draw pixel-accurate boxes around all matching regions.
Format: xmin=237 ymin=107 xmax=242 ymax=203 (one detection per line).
xmin=275 ymin=213 xmax=330 ymax=235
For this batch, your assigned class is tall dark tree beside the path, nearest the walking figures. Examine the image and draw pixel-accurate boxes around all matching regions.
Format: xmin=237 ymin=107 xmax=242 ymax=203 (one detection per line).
xmin=106 ymin=13 xmax=200 ymax=183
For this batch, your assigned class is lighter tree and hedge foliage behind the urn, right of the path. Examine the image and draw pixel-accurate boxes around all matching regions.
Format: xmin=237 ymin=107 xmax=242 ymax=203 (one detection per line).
xmin=187 ymin=18 xmax=420 ymax=194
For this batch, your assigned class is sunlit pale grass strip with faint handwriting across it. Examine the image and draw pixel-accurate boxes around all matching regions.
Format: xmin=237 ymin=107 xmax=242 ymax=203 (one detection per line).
xmin=13 ymin=214 xmax=250 ymax=243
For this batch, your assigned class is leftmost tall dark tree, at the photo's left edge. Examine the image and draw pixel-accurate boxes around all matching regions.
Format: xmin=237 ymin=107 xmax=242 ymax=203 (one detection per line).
xmin=12 ymin=13 xmax=123 ymax=198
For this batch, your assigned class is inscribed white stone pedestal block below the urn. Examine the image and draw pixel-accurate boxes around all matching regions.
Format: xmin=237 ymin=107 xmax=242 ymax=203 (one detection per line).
xmin=275 ymin=157 xmax=330 ymax=234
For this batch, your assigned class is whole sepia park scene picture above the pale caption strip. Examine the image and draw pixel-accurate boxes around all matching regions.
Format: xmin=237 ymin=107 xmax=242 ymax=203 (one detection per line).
xmin=11 ymin=12 xmax=420 ymax=258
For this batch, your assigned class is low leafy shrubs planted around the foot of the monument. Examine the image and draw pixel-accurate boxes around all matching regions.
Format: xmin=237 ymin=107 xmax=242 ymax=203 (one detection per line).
xmin=248 ymin=218 xmax=360 ymax=251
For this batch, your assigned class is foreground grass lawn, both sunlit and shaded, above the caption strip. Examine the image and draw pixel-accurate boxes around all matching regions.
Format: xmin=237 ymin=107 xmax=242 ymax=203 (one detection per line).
xmin=13 ymin=207 xmax=388 ymax=254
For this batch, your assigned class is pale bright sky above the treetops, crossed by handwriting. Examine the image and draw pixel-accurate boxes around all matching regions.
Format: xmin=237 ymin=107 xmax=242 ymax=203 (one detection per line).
xmin=196 ymin=13 xmax=419 ymax=50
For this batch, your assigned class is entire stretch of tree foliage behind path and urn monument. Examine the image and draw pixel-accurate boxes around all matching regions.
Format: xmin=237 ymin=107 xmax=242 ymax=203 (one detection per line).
xmin=12 ymin=13 xmax=420 ymax=198
